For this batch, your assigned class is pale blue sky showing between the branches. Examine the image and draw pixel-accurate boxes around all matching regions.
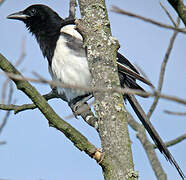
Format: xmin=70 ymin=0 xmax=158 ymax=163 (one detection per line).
xmin=0 ymin=0 xmax=186 ymax=180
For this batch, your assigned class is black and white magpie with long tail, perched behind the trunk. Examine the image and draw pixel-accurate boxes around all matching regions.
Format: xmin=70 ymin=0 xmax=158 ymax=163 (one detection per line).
xmin=7 ymin=4 xmax=185 ymax=179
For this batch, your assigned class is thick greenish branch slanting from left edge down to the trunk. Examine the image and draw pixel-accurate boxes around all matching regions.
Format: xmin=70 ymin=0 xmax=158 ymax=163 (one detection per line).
xmin=0 ymin=54 xmax=97 ymax=160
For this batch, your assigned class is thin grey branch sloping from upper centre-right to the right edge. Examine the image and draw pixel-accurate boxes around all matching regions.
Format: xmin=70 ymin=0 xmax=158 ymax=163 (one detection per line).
xmin=111 ymin=6 xmax=186 ymax=33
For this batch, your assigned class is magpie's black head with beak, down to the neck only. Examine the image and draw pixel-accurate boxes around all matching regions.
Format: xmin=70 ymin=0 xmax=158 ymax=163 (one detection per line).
xmin=7 ymin=4 xmax=63 ymax=36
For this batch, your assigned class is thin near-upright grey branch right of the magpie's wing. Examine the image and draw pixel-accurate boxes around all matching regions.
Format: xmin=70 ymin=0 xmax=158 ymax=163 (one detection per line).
xmin=147 ymin=18 xmax=179 ymax=119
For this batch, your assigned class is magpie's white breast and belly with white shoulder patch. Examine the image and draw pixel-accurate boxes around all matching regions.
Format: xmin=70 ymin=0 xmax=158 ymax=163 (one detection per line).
xmin=49 ymin=25 xmax=91 ymax=101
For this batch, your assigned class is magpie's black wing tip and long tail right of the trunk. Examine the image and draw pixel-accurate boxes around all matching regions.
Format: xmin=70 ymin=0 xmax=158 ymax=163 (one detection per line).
xmin=117 ymin=53 xmax=185 ymax=179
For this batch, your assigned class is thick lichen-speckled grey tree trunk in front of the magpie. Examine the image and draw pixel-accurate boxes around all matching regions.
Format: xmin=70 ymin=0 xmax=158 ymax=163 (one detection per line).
xmin=76 ymin=0 xmax=137 ymax=180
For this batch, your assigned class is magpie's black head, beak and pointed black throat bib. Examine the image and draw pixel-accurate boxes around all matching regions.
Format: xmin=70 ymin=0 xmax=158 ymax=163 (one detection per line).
xmin=7 ymin=4 xmax=64 ymax=64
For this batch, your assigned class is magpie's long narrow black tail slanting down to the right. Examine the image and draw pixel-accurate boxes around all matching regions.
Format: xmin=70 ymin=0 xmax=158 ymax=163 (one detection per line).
xmin=126 ymin=95 xmax=185 ymax=179
